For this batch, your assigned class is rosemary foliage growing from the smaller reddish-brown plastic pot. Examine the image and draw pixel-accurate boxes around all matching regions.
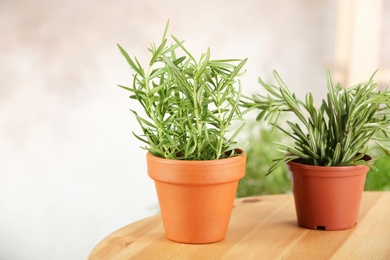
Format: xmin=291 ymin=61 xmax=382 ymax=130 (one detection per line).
xmin=241 ymin=71 xmax=390 ymax=174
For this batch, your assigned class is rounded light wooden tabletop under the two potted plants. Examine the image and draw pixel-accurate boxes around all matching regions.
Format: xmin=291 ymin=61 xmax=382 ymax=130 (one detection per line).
xmin=89 ymin=192 xmax=390 ymax=259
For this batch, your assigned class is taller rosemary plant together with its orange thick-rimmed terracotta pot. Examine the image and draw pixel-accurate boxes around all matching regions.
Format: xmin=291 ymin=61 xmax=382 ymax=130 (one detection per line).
xmin=118 ymin=22 xmax=246 ymax=243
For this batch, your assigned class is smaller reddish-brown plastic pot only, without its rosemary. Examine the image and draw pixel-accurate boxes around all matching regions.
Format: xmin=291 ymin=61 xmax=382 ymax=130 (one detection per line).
xmin=287 ymin=156 xmax=370 ymax=230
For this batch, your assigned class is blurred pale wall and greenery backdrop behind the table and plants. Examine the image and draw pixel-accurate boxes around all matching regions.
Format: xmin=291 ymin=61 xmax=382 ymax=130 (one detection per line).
xmin=0 ymin=0 xmax=390 ymax=260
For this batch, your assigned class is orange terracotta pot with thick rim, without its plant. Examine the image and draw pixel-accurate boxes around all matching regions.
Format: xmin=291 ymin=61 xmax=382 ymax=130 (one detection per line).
xmin=147 ymin=150 xmax=246 ymax=244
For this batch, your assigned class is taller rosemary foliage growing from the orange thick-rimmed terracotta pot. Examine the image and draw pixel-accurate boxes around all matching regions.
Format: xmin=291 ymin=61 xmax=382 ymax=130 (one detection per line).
xmin=118 ymin=21 xmax=247 ymax=160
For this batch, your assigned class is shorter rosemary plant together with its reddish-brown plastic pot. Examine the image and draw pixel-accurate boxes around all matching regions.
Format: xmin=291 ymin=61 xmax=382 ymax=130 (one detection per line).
xmin=241 ymin=71 xmax=390 ymax=230
